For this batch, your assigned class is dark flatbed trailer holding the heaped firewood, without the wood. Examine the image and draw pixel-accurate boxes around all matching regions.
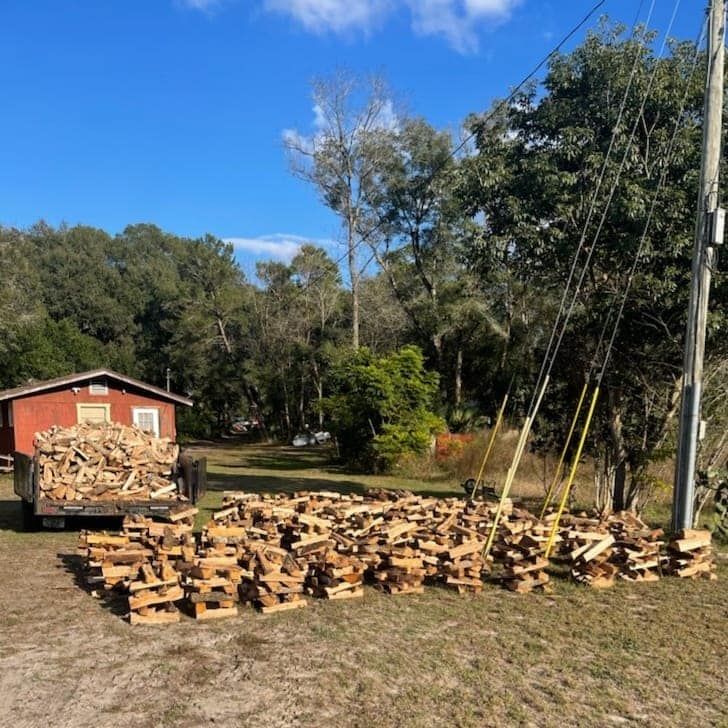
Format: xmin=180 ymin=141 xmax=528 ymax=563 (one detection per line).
xmin=13 ymin=451 xmax=207 ymax=530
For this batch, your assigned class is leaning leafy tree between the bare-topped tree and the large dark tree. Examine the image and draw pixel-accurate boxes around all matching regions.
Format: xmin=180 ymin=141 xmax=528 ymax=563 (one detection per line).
xmin=368 ymin=119 xmax=492 ymax=407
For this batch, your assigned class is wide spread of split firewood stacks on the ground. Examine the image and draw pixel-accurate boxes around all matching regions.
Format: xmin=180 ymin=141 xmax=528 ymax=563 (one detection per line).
xmin=72 ymin=491 xmax=715 ymax=624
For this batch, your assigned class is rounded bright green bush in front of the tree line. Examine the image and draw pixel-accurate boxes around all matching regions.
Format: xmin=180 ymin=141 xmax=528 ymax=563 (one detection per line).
xmin=324 ymin=346 xmax=445 ymax=471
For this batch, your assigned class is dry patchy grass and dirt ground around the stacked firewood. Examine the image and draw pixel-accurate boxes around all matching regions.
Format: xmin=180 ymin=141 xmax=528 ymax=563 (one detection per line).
xmin=0 ymin=448 xmax=728 ymax=728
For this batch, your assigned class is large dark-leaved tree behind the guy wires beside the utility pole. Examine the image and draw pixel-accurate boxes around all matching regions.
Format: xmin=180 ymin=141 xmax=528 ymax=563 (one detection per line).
xmin=460 ymin=25 xmax=725 ymax=508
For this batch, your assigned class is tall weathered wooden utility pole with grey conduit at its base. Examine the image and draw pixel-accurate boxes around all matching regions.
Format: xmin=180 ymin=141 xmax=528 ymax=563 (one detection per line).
xmin=672 ymin=0 xmax=725 ymax=531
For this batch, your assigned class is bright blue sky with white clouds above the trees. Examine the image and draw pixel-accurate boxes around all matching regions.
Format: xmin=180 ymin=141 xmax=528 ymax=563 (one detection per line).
xmin=0 ymin=0 xmax=704 ymax=269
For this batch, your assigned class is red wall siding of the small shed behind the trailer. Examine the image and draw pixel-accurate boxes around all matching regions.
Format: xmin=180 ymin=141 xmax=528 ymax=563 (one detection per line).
xmin=0 ymin=380 xmax=177 ymax=454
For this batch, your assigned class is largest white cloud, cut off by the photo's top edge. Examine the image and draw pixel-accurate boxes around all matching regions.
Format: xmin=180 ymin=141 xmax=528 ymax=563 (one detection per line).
xmin=262 ymin=0 xmax=523 ymax=53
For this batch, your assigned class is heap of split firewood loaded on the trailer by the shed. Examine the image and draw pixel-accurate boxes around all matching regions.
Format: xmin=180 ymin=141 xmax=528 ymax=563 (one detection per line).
xmin=35 ymin=423 xmax=182 ymax=501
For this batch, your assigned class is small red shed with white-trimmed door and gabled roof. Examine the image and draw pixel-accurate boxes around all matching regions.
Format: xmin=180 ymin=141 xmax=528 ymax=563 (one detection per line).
xmin=0 ymin=369 xmax=192 ymax=455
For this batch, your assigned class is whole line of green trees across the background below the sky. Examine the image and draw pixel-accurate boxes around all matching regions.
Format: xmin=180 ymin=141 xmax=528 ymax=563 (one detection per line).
xmin=0 ymin=21 xmax=728 ymax=507
